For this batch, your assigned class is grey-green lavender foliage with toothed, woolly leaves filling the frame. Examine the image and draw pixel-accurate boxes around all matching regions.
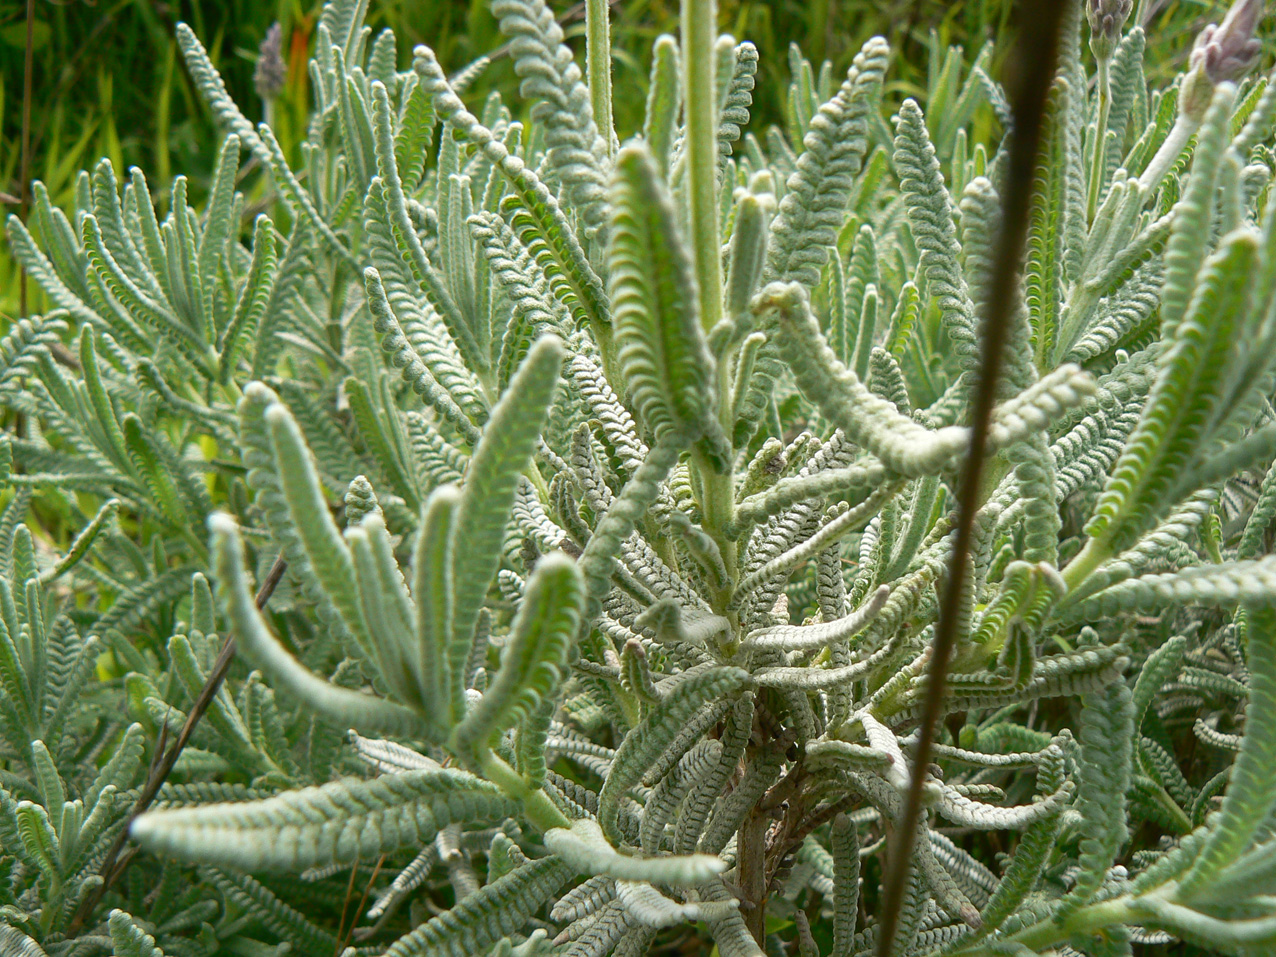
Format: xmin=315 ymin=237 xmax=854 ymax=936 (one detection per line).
xmin=0 ymin=0 xmax=1276 ymax=957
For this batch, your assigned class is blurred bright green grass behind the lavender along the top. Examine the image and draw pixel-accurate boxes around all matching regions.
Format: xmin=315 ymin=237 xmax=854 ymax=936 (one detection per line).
xmin=0 ymin=0 xmax=1226 ymax=322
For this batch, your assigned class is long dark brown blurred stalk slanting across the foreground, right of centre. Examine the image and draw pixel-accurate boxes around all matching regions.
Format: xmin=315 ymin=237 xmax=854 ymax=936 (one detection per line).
xmin=877 ymin=0 xmax=1067 ymax=957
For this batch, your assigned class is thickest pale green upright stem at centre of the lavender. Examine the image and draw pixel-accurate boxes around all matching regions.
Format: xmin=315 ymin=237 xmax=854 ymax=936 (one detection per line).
xmin=681 ymin=0 xmax=736 ymax=602
